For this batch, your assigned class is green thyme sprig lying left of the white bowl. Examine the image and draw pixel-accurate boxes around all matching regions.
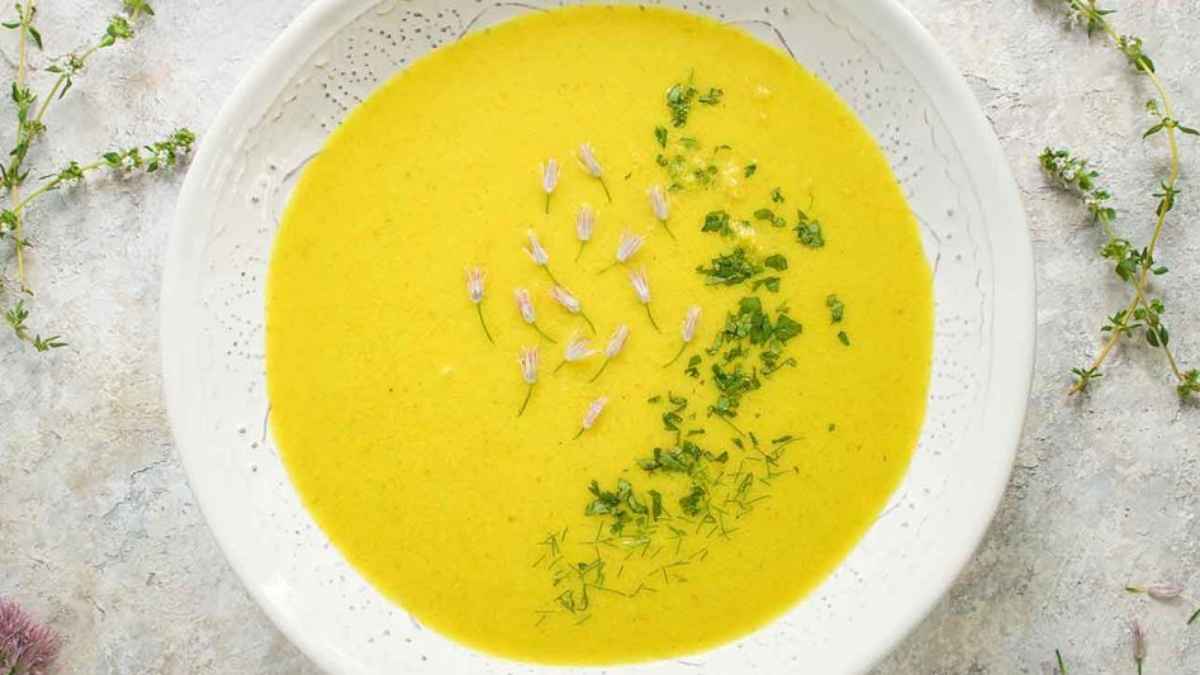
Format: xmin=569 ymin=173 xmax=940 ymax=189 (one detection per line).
xmin=0 ymin=0 xmax=196 ymax=352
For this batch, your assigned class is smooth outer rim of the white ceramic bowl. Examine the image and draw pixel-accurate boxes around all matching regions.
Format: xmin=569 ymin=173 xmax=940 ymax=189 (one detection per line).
xmin=158 ymin=0 xmax=1037 ymax=673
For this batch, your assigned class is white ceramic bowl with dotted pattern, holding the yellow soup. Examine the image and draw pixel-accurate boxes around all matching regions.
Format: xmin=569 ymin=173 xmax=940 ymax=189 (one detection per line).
xmin=162 ymin=0 xmax=1034 ymax=675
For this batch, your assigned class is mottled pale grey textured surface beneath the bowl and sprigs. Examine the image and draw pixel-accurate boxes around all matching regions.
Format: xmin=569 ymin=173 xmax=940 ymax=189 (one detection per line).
xmin=0 ymin=0 xmax=1200 ymax=675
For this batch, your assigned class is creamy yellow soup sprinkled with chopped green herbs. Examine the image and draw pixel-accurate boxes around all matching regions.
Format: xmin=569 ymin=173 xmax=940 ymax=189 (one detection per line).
xmin=268 ymin=6 xmax=932 ymax=664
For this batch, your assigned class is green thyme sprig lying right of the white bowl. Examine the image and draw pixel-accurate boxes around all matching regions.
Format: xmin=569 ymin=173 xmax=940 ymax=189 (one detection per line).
xmin=1039 ymin=0 xmax=1200 ymax=399
